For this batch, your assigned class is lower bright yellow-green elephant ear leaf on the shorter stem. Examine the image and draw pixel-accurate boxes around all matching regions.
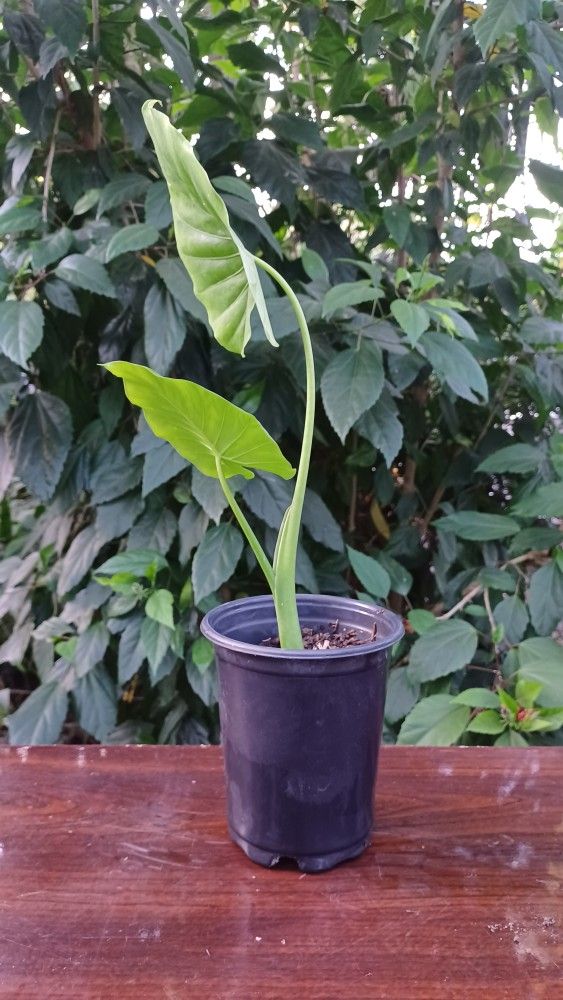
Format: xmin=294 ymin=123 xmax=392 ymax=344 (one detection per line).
xmin=106 ymin=361 xmax=294 ymax=479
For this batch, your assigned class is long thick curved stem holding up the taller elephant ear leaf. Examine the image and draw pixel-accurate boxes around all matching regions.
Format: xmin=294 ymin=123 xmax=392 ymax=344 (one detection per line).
xmin=254 ymin=257 xmax=316 ymax=649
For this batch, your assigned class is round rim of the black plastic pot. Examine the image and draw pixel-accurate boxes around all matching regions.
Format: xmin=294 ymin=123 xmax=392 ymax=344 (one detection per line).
xmin=200 ymin=594 xmax=405 ymax=662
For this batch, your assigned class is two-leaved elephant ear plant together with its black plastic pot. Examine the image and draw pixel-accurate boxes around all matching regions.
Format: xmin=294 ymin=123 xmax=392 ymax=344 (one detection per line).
xmin=106 ymin=101 xmax=403 ymax=871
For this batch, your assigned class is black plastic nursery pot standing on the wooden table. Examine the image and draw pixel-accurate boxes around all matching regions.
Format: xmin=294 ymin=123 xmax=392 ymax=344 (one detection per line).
xmin=201 ymin=595 xmax=403 ymax=872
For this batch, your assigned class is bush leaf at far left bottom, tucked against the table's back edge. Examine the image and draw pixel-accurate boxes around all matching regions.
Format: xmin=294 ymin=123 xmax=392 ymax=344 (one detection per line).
xmin=5 ymin=681 xmax=68 ymax=746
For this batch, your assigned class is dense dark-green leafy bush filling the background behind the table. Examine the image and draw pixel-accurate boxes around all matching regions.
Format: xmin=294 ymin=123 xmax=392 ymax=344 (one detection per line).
xmin=0 ymin=0 xmax=563 ymax=744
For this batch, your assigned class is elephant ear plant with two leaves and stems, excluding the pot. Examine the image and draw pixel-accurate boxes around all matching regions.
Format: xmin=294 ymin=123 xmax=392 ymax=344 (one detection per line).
xmin=105 ymin=101 xmax=315 ymax=649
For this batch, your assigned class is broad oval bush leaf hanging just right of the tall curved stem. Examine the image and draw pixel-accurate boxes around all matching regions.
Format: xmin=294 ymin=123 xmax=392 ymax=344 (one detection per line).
xmin=321 ymin=339 xmax=384 ymax=443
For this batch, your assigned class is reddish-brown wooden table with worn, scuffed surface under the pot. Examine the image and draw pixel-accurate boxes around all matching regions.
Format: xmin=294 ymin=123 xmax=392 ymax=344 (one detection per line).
xmin=0 ymin=746 xmax=563 ymax=1000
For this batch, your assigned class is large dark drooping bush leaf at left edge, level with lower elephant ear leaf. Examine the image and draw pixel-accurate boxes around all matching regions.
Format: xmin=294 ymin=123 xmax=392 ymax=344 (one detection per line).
xmin=8 ymin=389 xmax=72 ymax=500
